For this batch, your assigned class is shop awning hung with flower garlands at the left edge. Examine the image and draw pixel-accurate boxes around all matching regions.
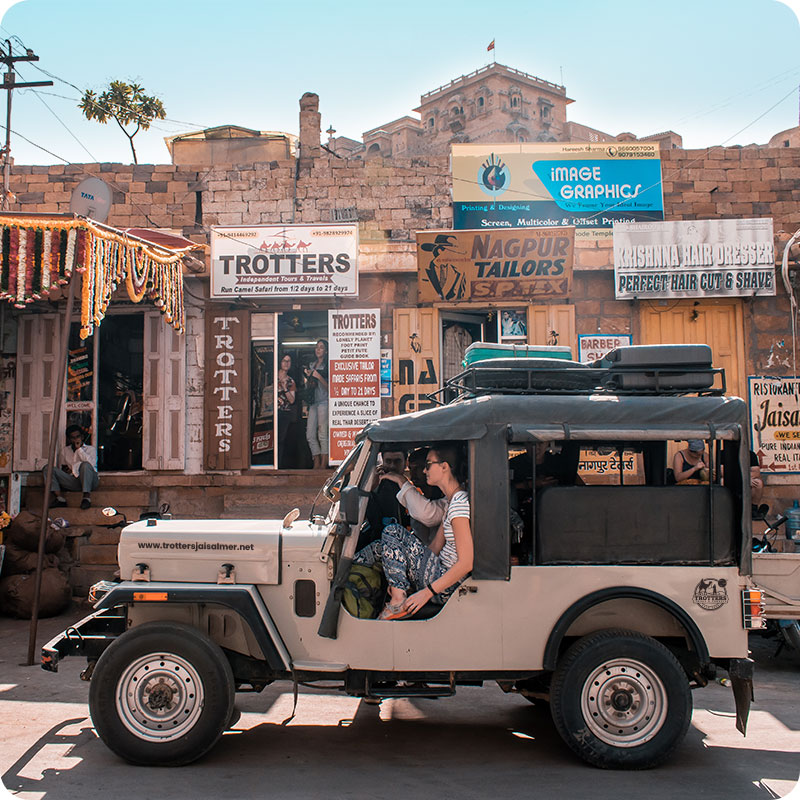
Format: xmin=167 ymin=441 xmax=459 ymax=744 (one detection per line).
xmin=0 ymin=213 xmax=197 ymax=339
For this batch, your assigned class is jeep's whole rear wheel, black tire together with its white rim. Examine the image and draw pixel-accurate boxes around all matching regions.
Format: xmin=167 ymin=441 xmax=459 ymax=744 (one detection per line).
xmin=550 ymin=630 xmax=692 ymax=769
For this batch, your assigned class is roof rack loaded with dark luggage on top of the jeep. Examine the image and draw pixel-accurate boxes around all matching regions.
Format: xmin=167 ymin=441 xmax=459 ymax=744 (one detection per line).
xmin=429 ymin=345 xmax=726 ymax=403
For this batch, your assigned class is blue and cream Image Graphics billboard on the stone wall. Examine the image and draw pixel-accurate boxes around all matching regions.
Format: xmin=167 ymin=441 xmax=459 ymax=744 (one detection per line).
xmin=451 ymin=142 xmax=664 ymax=239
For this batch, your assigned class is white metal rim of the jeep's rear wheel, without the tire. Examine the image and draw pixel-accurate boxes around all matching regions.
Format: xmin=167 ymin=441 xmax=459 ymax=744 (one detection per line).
xmin=581 ymin=658 xmax=668 ymax=747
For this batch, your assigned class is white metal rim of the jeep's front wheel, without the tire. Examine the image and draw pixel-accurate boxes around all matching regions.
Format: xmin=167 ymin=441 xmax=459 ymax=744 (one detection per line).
xmin=116 ymin=653 xmax=204 ymax=742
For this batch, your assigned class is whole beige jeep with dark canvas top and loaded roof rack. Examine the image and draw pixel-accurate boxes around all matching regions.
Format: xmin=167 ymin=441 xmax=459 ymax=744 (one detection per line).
xmin=42 ymin=346 xmax=763 ymax=768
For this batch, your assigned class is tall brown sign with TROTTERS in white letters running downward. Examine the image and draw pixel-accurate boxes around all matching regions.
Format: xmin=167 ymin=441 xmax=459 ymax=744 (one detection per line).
xmin=204 ymin=304 xmax=250 ymax=469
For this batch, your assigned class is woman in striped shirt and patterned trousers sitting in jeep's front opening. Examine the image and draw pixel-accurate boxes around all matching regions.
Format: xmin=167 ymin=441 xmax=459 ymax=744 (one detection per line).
xmin=354 ymin=444 xmax=473 ymax=619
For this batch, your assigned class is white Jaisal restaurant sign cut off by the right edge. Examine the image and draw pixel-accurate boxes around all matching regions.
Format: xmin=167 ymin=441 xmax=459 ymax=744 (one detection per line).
xmin=747 ymin=376 xmax=800 ymax=474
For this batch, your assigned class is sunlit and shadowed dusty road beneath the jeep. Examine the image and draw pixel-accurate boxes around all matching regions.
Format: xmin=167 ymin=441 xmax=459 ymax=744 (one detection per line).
xmin=0 ymin=609 xmax=800 ymax=800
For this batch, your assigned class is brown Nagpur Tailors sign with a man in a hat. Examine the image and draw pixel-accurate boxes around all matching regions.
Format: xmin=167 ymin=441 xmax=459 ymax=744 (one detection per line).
xmin=417 ymin=228 xmax=575 ymax=303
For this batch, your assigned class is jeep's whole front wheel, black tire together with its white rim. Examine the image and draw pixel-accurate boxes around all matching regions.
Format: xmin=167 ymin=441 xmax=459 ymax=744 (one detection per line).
xmin=89 ymin=622 xmax=234 ymax=766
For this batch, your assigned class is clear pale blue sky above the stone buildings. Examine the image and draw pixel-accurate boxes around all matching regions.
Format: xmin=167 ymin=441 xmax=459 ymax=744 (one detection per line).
xmin=0 ymin=0 xmax=800 ymax=164
